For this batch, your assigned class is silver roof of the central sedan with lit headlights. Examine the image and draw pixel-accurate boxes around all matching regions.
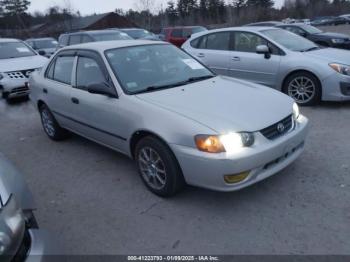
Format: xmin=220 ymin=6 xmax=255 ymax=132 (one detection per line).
xmin=61 ymin=40 xmax=170 ymax=53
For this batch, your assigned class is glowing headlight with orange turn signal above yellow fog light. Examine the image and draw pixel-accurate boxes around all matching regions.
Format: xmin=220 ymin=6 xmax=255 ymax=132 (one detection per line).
xmin=195 ymin=132 xmax=254 ymax=153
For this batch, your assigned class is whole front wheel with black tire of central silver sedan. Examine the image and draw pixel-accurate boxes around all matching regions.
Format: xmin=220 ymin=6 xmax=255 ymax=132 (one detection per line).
xmin=135 ymin=136 xmax=185 ymax=197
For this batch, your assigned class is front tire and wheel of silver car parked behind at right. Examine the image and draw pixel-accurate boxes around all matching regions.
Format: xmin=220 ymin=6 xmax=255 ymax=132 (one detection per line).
xmin=283 ymin=72 xmax=322 ymax=106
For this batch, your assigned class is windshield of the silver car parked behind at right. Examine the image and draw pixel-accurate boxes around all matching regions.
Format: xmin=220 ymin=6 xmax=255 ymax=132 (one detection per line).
xmin=261 ymin=29 xmax=318 ymax=52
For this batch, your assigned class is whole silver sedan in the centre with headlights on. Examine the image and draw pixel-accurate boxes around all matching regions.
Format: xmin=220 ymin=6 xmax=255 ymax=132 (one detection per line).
xmin=30 ymin=40 xmax=308 ymax=196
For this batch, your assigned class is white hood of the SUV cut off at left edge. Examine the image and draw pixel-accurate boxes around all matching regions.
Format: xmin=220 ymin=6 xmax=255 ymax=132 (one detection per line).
xmin=0 ymin=55 xmax=48 ymax=72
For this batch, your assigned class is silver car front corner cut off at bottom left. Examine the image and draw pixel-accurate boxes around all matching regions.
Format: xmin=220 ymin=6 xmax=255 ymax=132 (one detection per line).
xmin=0 ymin=153 xmax=52 ymax=262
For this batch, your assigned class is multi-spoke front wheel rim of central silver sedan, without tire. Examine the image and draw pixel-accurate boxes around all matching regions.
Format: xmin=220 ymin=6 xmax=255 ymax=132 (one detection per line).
xmin=138 ymin=147 xmax=167 ymax=190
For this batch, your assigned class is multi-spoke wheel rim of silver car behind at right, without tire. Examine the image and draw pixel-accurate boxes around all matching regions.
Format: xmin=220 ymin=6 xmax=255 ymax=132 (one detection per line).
xmin=288 ymin=76 xmax=316 ymax=104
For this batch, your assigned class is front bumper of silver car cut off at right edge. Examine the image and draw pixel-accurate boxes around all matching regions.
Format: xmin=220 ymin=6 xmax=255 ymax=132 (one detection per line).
xmin=321 ymin=72 xmax=350 ymax=101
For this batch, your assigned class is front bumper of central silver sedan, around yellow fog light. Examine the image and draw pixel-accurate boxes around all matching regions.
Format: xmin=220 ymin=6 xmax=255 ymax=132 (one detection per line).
xmin=171 ymin=115 xmax=308 ymax=192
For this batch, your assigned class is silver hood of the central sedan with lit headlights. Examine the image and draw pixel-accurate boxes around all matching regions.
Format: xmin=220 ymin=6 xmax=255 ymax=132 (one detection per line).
xmin=137 ymin=76 xmax=293 ymax=134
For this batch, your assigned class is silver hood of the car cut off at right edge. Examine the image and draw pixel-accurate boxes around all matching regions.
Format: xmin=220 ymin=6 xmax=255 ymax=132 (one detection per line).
xmin=303 ymin=48 xmax=350 ymax=64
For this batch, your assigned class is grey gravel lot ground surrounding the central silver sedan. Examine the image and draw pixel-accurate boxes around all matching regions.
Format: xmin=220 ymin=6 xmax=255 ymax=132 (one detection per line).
xmin=0 ymin=97 xmax=350 ymax=254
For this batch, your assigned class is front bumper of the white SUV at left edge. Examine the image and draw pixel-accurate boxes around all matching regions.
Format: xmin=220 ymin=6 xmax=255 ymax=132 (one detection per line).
xmin=0 ymin=78 xmax=30 ymax=98
